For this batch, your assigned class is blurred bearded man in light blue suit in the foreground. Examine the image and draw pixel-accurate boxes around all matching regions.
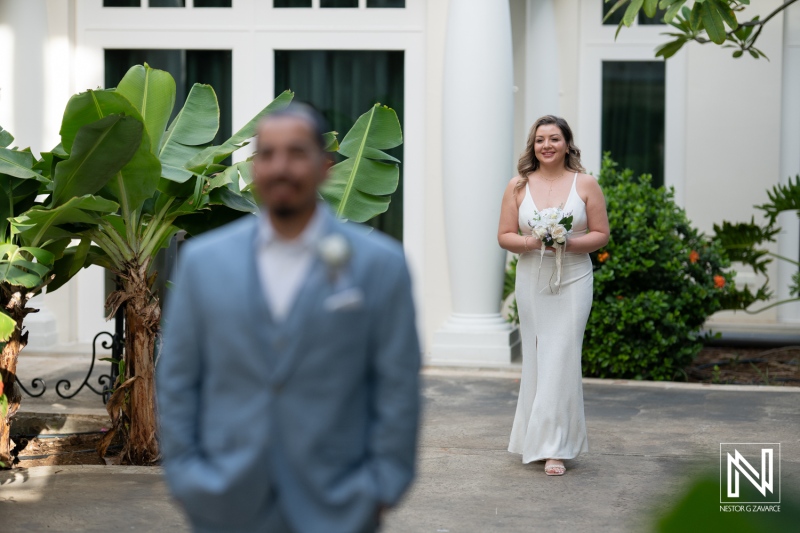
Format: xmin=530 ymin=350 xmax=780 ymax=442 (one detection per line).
xmin=157 ymin=106 xmax=420 ymax=533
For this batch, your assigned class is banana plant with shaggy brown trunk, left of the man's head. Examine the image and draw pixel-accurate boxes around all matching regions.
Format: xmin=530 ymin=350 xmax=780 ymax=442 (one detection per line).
xmin=27 ymin=64 xmax=291 ymax=464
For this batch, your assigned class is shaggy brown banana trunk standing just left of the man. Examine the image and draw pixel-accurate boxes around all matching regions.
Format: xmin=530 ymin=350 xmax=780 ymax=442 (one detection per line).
xmin=123 ymin=266 xmax=161 ymax=465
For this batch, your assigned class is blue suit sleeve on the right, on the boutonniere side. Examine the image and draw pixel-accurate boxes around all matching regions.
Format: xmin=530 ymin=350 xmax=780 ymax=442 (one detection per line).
xmin=370 ymin=251 xmax=421 ymax=506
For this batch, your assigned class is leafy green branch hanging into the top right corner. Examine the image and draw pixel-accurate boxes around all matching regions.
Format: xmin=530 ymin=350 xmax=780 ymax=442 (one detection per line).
xmin=604 ymin=0 xmax=797 ymax=59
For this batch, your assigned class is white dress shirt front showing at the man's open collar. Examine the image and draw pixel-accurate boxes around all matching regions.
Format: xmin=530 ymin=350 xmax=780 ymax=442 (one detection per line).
xmin=256 ymin=207 xmax=324 ymax=321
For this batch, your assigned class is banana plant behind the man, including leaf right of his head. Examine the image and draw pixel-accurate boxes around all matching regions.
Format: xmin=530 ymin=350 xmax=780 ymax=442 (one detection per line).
xmin=0 ymin=64 xmax=402 ymax=464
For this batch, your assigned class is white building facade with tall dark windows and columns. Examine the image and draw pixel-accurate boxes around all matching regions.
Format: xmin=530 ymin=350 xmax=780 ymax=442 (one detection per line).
xmin=0 ymin=0 xmax=800 ymax=364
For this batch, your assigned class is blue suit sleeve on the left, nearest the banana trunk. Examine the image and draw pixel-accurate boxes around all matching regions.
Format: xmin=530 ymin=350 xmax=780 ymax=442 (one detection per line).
xmin=156 ymin=244 xmax=224 ymax=516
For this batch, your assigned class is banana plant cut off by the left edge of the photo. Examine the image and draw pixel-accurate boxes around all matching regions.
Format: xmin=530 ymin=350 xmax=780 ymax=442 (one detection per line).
xmin=0 ymin=115 xmax=134 ymax=466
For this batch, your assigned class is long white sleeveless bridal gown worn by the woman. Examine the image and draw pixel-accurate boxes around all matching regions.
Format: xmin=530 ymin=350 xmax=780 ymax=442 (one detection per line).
xmin=508 ymin=173 xmax=593 ymax=463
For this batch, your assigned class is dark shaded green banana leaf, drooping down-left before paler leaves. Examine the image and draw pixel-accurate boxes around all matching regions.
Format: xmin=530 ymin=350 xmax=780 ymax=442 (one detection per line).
xmin=52 ymin=115 xmax=142 ymax=207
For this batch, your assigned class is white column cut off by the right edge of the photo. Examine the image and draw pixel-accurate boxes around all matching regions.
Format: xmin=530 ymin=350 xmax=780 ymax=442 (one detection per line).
xmin=776 ymin=7 xmax=800 ymax=324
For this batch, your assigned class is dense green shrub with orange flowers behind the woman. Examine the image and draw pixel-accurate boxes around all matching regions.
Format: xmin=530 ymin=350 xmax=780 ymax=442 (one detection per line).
xmin=506 ymin=155 xmax=736 ymax=380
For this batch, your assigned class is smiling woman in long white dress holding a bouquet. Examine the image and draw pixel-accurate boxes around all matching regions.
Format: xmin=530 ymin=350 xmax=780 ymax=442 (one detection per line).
xmin=497 ymin=115 xmax=609 ymax=476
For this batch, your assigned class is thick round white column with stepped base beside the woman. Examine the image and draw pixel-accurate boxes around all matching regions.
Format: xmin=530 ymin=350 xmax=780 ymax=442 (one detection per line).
xmin=431 ymin=0 xmax=520 ymax=364
